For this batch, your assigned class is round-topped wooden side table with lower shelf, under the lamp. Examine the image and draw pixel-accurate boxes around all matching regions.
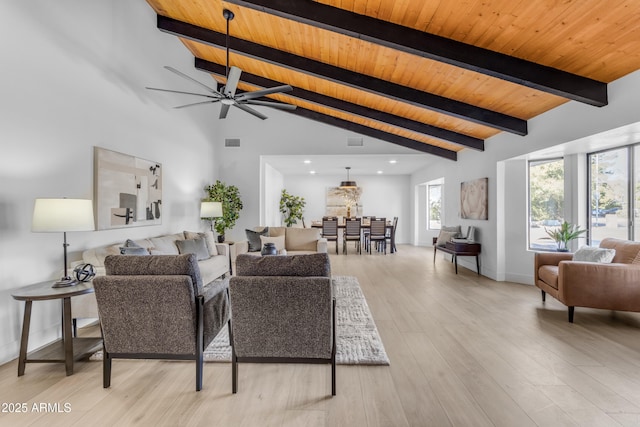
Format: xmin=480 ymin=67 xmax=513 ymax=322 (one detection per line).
xmin=11 ymin=281 xmax=102 ymax=377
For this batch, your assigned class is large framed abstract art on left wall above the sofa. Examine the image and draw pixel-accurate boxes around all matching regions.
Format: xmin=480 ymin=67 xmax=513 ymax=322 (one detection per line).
xmin=94 ymin=147 xmax=162 ymax=230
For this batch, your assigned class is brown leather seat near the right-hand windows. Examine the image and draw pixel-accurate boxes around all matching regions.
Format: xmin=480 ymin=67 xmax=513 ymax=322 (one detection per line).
xmin=534 ymin=238 xmax=640 ymax=323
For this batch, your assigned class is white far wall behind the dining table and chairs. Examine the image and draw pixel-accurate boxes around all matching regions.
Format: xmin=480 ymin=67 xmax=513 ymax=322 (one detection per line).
xmin=284 ymin=175 xmax=412 ymax=243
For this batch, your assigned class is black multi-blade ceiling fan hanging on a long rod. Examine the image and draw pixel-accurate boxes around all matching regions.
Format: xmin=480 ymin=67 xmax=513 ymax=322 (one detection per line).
xmin=146 ymin=9 xmax=296 ymax=120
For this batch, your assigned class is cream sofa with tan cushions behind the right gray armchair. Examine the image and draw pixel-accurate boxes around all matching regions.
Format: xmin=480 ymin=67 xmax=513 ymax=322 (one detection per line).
xmin=231 ymin=226 xmax=327 ymax=273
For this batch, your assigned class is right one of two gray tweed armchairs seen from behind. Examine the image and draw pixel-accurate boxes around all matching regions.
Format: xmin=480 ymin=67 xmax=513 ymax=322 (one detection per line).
xmin=229 ymin=253 xmax=336 ymax=396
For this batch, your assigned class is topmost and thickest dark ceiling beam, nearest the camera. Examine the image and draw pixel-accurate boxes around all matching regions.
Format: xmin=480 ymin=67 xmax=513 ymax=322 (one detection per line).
xmin=226 ymin=0 xmax=607 ymax=107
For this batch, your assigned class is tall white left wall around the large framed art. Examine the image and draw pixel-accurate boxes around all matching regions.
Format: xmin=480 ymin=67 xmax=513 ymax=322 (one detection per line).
xmin=0 ymin=0 xmax=222 ymax=363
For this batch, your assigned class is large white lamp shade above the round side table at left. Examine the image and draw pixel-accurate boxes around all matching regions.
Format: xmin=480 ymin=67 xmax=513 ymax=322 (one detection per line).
xmin=31 ymin=199 xmax=95 ymax=233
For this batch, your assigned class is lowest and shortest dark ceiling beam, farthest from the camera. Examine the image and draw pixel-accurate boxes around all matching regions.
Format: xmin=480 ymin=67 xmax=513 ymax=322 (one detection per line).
xmin=285 ymin=107 xmax=458 ymax=161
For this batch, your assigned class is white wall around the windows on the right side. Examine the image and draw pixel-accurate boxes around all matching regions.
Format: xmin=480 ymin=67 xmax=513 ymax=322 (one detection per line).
xmin=411 ymin=72 xmax=640 ymax=283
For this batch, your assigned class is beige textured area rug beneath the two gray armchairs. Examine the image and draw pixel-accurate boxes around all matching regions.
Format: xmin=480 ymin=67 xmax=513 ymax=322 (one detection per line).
xmin=91 ymin=276 xmax=389 ymax=365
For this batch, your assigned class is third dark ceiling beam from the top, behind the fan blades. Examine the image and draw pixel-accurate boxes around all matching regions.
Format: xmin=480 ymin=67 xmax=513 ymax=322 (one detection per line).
xmin=195 ymin=58 xmax=484 ymax=151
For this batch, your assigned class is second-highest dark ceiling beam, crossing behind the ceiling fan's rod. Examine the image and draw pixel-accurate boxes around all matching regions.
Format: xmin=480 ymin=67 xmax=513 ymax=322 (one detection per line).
xmin=158 ymin=15 xmax=527 ymax=135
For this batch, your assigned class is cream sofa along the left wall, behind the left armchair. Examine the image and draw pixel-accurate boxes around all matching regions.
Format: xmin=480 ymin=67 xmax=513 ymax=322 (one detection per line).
xmin=71 ymin=231 xmax=230 ymax=319
